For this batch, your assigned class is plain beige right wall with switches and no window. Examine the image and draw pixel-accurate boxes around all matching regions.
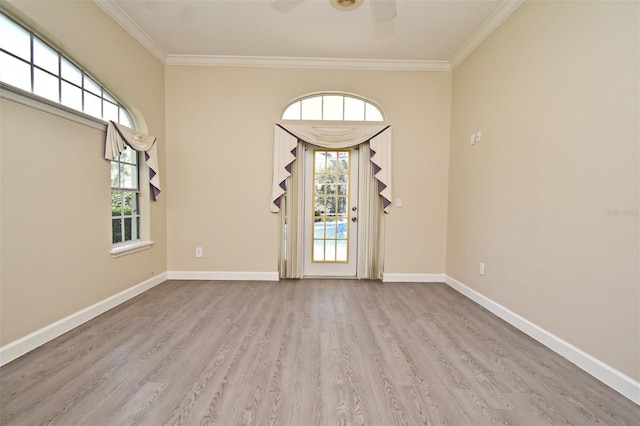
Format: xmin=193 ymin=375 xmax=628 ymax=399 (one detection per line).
xmin=447 ymin=2 xmax=640 ymax=380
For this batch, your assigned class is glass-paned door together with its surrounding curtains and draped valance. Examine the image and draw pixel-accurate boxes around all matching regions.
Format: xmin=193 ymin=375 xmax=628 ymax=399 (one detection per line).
xmin=271 ymin=124 xmax=392 ymax=279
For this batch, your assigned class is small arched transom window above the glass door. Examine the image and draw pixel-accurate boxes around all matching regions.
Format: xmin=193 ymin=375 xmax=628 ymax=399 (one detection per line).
xmin=282 ymin=93 xmax=384 ymax=121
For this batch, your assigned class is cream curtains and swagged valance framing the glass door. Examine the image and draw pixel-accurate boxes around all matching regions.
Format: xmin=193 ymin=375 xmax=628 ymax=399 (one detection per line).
xmin=271 ymin=125 xmax=391 ymax=278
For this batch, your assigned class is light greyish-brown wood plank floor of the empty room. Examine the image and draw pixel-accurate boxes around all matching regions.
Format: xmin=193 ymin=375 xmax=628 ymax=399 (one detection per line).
xmin=0 ymin=280 xmax=640 ymax=426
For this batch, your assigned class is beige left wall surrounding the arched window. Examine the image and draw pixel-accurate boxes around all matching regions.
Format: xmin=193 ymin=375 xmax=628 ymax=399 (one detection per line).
xmin=0 ymin=1 xmax=167 ymax=345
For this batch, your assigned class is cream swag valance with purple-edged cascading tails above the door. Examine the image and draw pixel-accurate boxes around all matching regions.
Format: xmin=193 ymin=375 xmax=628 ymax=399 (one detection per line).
xmin=271 ymin=124 xmax=391 ymax=213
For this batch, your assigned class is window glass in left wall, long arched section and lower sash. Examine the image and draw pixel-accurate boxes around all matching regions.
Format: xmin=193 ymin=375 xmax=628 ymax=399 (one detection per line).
xmin=0 ymin=13 xmax=141 ymax=253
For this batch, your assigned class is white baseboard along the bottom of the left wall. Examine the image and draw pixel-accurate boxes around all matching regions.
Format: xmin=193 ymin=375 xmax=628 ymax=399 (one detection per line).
xmin=0 ymin=273 xmax=167 ymax=366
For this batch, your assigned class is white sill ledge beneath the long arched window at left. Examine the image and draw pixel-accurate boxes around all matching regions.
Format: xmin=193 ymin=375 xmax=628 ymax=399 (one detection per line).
xmin=0 ymin=82 xmax=107 ymax=131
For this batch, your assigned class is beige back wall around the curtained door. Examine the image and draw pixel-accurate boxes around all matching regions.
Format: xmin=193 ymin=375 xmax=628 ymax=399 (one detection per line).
xmin=166 ymin=66 xmax=451 ymax=273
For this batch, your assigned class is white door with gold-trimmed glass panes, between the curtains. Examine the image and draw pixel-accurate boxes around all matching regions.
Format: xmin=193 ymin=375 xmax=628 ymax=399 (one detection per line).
xmin=303 ymin=146 xmax=358 ymax=277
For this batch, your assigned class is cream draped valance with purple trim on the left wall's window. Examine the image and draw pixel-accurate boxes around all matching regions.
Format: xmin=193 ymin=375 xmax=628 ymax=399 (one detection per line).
xmin=104 ymin=121 xmax=161 ymax=200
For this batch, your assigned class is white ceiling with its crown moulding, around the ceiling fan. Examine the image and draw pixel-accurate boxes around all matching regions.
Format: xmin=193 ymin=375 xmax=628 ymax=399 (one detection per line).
xmin=95 ymin=0 xmax=522 ymax=69
